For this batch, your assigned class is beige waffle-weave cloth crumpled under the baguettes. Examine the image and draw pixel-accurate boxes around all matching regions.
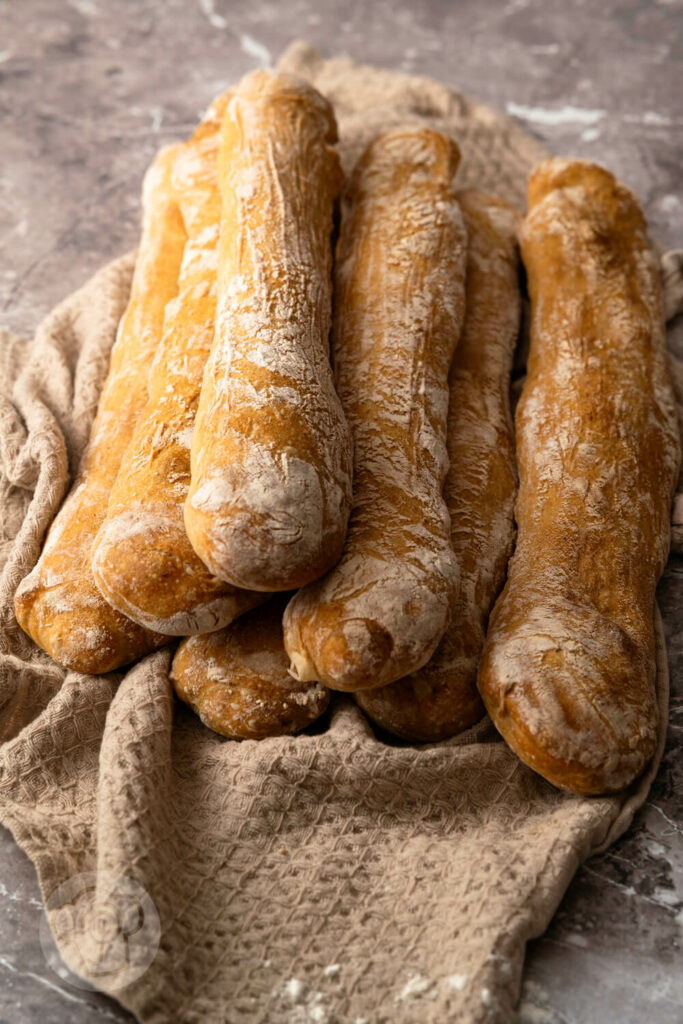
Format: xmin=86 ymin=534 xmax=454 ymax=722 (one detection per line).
xmin=0 ymin=44 xmax=683 ymax=1024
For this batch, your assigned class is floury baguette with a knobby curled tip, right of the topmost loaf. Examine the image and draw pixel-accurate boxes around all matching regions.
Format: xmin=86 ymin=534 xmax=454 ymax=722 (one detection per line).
xmin=285 ymin=128 xmax=466 ymax=690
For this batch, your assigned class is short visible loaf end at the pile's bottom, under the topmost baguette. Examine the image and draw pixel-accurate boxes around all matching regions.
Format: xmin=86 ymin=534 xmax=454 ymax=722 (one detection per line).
xmin=171 ymin=595 xmax=330 ymax=739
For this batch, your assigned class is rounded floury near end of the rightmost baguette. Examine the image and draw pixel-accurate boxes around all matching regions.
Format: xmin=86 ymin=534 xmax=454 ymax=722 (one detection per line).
xmin=479 ymin=599 xmax=657 ymax=796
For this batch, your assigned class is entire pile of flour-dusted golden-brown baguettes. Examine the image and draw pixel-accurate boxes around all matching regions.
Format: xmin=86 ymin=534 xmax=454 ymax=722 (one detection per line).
xmin=15 ymin=71 xmax=679 ymax=793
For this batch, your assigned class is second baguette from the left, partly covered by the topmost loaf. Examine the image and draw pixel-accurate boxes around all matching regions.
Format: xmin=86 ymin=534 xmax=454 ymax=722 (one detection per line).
xmin=92 ymin=94 xmax=263 ymax=636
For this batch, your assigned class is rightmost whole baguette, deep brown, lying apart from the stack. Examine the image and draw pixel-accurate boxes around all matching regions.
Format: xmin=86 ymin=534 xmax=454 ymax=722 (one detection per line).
xmin=479 ymin=160 xmax=680 ymax=794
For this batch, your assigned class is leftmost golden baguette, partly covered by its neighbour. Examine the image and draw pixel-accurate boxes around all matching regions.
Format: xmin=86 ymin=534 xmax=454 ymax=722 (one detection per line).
xmin=14 ymin=146 xmax=185 ymax=673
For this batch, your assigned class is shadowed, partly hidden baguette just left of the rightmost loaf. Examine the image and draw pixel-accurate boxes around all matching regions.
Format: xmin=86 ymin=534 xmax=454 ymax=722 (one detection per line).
xmin=355 ymin=190 xmax=520 ymax=741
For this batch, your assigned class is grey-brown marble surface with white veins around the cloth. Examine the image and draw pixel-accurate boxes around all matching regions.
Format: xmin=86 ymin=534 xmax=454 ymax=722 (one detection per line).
xmin=0 ymin=0 xmax=683 ymax=1024
